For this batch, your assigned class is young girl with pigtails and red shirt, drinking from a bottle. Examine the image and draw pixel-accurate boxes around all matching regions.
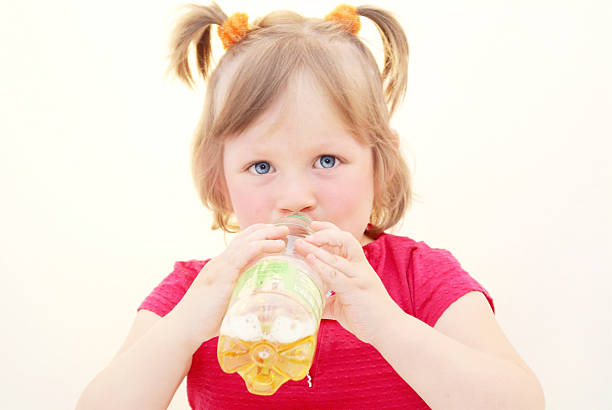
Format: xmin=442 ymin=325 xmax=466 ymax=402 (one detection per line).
xmin=79 ymin=3 xmax=544 ymax=409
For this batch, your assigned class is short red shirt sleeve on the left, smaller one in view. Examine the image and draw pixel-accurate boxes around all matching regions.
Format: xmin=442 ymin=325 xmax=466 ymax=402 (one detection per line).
xmin=137 ymin=259 xmax=210 ymax=317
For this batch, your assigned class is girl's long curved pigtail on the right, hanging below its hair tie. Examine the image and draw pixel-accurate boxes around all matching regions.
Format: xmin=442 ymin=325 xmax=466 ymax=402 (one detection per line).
xmin=357 ymin=6 xmax=409 ymax=115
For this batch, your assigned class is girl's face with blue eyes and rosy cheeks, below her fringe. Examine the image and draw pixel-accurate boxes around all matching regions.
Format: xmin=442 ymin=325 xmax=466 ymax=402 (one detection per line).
xmin=223 ymin=77 xmax=374 ymax=245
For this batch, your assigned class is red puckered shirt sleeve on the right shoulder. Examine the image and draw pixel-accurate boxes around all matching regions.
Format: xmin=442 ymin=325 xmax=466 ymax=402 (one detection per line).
xmin=409 ymin=242 xmax=495 ymax=327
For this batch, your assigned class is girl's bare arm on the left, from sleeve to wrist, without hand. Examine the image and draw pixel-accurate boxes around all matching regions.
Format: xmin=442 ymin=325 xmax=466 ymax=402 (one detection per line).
xmin=77 ymin=310 xmax=197 ymax=409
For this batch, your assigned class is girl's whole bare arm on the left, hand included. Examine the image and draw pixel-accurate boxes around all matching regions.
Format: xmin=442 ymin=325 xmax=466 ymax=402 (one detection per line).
xmin=77 ymin=224 xmax=289 ymax=410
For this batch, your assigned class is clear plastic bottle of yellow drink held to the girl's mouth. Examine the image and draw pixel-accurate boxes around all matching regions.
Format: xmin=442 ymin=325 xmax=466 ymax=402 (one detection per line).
xmin=217 ymin=214 xmax=326 ymax=395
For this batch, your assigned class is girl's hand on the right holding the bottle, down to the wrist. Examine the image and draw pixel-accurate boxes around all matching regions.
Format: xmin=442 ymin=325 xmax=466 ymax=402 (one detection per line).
xmin=295 ymin=221 xmax=399 ymax=343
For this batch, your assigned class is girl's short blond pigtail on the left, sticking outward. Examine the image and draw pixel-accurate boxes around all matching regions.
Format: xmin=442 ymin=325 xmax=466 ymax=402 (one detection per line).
xmin=166 ymin=2 xmax=227 ymax=88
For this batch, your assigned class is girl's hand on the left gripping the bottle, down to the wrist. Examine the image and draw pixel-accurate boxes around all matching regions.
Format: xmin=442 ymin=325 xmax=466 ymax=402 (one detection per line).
xmin=173 ymin=224 xmax=289 ymax=348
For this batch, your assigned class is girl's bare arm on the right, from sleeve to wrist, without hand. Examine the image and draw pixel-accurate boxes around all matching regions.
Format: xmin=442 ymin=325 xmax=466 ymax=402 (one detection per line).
xmin=372 ymin=292 xmax=544 ymax=410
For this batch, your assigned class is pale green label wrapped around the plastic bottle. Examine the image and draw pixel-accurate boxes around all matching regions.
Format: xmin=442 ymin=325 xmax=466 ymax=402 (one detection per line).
xmin=230 ymin=260 xmax=323 ymax=321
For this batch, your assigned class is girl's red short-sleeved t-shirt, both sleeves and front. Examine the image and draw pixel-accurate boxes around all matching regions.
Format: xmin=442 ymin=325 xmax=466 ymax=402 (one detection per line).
xmin=139 ymin=233 xmax=494 ymax=409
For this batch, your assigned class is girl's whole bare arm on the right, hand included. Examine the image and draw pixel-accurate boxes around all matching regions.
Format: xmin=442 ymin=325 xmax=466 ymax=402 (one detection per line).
xmin=295 ymin=221 xmax=544 ymax=410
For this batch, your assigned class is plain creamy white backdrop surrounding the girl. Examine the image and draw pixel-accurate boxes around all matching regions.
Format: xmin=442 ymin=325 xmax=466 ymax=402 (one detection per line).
xmin=0 ymin=0 xmax=612 ymax=409
